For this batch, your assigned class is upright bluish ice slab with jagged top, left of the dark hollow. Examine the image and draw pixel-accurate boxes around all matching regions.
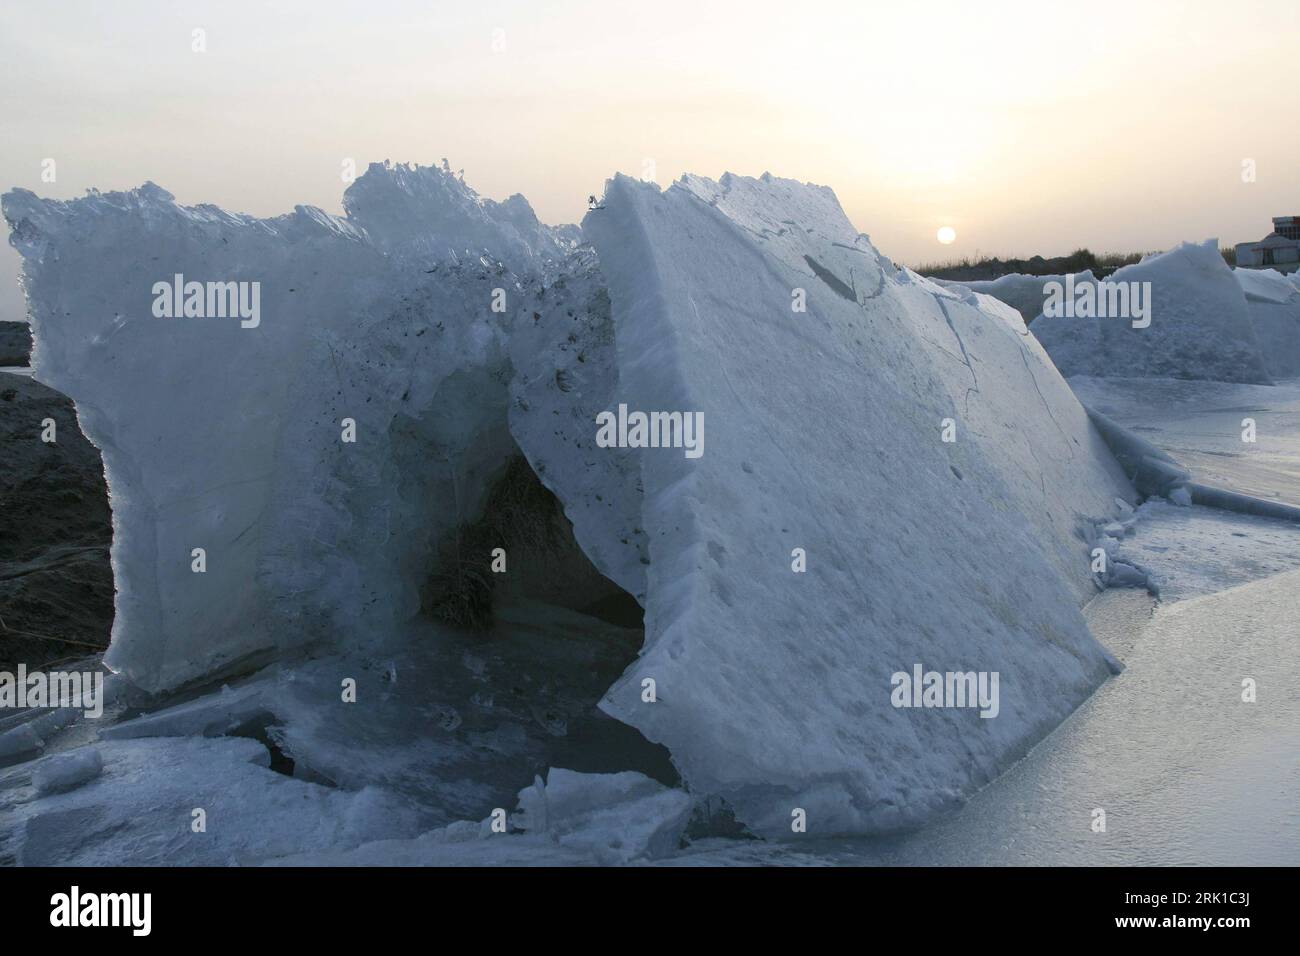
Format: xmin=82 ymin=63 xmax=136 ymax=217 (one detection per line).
xmin=4 ymin=164 xmax=569 ymax=689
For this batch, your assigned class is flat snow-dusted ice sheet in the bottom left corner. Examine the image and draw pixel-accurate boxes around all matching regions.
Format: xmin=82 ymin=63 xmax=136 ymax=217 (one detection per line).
xmin=0 ymin=737 xmax=420 ymax=866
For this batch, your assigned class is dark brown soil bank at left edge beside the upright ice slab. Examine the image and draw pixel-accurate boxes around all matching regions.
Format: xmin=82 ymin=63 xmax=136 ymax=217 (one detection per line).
xmin=0 ymin=369 xmax=113 ymax=671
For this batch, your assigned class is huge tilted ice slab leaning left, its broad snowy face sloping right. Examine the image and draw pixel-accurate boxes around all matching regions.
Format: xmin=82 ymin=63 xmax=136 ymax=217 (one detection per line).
xmin=585 ymin=176 xmax=1131 ymax=835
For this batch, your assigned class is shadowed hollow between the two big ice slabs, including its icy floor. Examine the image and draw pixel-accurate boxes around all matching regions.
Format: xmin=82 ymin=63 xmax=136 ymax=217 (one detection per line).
xmin=87 ymin=434 xmax=681 ymax=826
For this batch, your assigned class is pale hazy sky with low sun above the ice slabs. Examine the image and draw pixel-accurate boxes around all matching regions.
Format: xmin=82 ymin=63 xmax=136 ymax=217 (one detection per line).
xmin=0 ymin=0 xmax=1300 ymax=319
